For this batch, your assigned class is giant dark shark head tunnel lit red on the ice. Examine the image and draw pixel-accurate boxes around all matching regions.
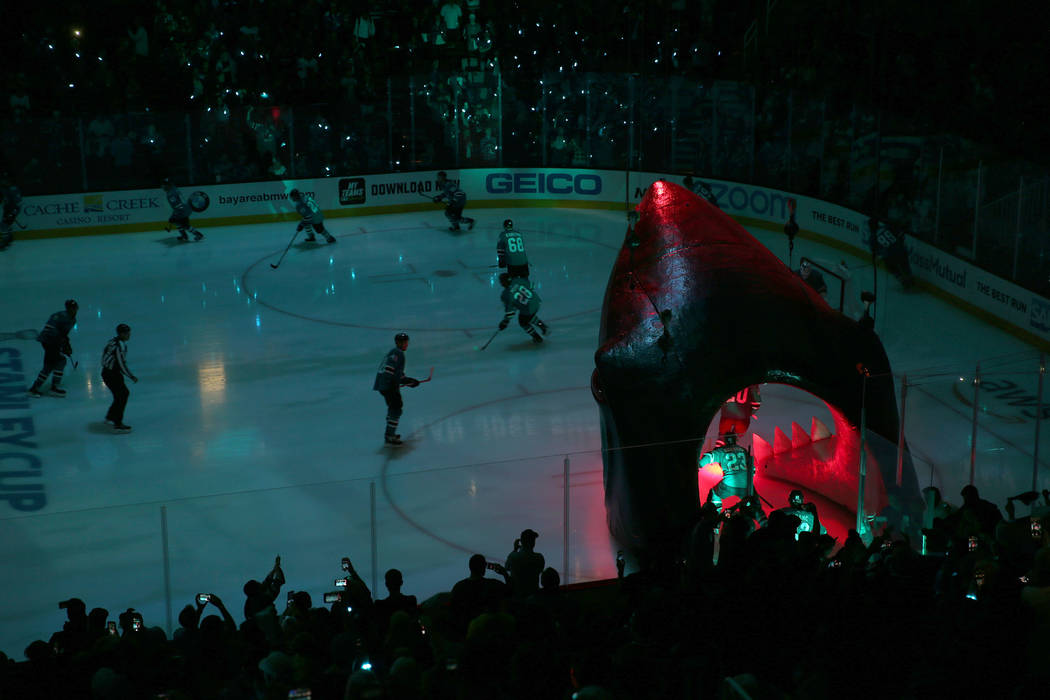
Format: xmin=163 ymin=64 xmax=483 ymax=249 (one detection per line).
xmin=591 ymin=181 xmax=920 ymax=553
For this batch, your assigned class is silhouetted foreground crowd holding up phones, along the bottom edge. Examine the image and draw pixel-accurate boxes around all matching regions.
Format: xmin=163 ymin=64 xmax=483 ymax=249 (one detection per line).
xmin=0 ymin=487 xmax=1050 ymax=700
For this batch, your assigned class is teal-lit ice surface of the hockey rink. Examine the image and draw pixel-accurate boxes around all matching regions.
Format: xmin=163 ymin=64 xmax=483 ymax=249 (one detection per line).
xmin=0 ymin=203 xmax=1048 ymax=659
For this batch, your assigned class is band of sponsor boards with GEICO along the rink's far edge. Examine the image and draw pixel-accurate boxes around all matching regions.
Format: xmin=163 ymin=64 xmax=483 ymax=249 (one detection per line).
xmin=14 ymin=168 xmax=1050 ymax=341
